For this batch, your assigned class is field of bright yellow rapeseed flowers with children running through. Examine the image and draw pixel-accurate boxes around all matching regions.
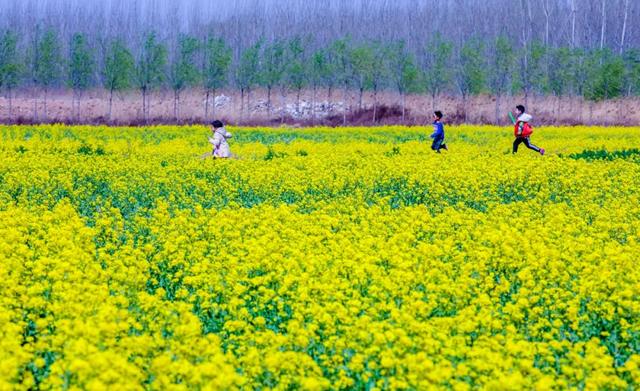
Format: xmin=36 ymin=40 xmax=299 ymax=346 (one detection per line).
xmin=0 ymin=125 xmax=640 ymax=390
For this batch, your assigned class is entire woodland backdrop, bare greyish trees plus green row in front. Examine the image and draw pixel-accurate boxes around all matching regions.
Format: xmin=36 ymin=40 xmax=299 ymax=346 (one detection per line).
xmin=0 ymin=0 xmax=640 ymax=121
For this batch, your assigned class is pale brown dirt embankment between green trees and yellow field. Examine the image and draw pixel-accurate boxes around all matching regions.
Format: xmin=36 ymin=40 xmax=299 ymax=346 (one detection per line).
xmin=0 ymin=90 xmax=640 ymax=126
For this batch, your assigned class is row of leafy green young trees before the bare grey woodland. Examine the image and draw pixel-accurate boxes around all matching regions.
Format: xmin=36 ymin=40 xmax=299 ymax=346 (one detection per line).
xmin=0 ymin=26 xmax=640 ymax=123
